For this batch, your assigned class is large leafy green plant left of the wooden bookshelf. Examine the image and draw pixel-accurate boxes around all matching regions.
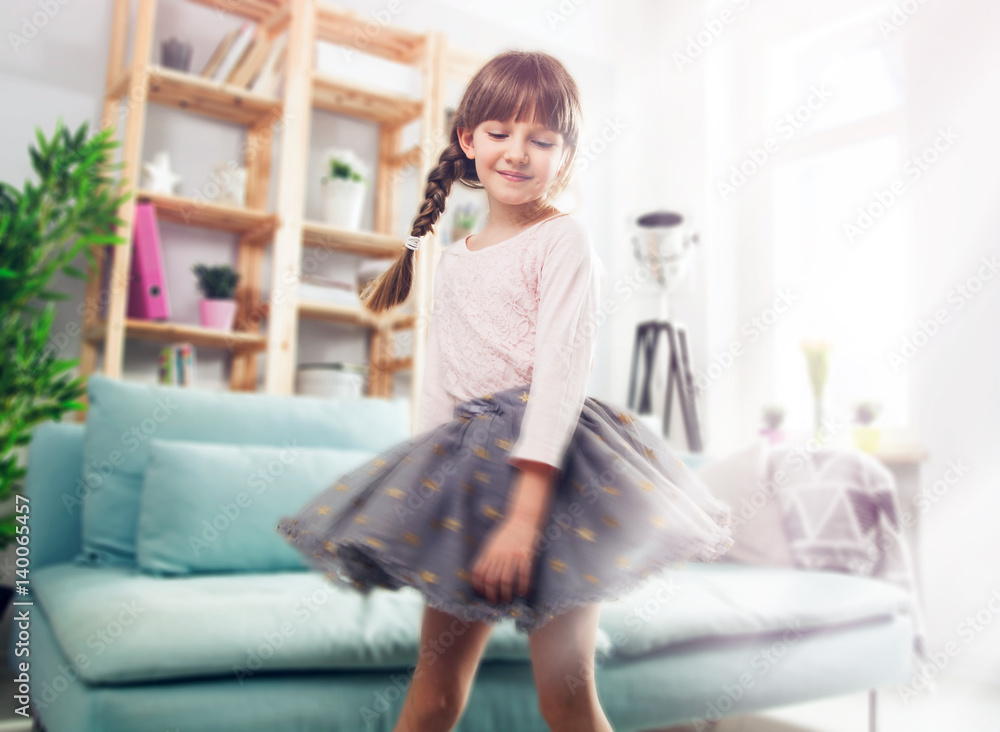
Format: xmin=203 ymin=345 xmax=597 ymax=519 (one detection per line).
xmin=0 ymin=120 xmax=131 ymax=615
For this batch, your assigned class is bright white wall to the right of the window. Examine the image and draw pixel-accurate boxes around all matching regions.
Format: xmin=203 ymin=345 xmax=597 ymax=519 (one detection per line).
xmin=903 ymin=0 xmax=1000 ymax=683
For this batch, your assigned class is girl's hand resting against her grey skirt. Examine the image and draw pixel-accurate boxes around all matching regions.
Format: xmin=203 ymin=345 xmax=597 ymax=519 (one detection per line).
xmin=472 ymin=516 xmax=536 ymax=605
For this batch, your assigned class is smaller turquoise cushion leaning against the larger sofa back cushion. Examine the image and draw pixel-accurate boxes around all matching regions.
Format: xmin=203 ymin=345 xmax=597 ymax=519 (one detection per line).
xmin=136 ymin=439 xmax=376 ymax=575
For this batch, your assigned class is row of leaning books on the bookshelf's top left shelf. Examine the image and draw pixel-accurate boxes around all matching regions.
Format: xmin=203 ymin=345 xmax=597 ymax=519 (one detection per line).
xmin=201 ymin=21 xmax=288 ymax=96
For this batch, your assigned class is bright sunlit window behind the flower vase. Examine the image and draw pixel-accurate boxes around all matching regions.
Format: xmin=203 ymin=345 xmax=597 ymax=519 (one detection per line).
xmin=765 ymin=8 xmax=916 ymax=430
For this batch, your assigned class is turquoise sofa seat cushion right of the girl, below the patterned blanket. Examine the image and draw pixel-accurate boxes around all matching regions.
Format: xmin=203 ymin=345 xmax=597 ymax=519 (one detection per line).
xmin=600 ymin=562 xmax=909 ymax=657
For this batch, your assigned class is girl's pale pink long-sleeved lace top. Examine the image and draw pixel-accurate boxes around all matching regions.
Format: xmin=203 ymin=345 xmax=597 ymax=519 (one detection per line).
xmin=417 ymin=214 xmax=605 ymax=468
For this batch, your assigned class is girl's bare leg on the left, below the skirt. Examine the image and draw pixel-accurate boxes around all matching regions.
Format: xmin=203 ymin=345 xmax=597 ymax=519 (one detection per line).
xmin=393 ymin=606 xmax=493 ymax=732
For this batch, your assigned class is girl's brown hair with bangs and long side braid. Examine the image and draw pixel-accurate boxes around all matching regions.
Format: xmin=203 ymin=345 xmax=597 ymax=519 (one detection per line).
xmin=360 ymin=51 xmax=581 ymax=313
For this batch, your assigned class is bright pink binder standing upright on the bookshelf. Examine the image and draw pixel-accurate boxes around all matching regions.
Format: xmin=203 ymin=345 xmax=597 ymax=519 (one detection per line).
xmin=128 ymin=201 xmax=170 ymax=320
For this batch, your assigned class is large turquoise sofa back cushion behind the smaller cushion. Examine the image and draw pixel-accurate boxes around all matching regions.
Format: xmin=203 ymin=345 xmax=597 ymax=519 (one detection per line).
xmin=76 ymin=374 xmax=412 ymax=567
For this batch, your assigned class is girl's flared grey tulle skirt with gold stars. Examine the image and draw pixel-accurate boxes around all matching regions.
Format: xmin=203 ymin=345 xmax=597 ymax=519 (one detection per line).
xmin=277 ymin=384 xmax=733 ymax=634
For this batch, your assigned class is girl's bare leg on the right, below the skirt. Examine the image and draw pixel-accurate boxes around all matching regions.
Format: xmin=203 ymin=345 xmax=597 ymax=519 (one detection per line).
xmin=528 ymin=602 xmax=614 ymax=732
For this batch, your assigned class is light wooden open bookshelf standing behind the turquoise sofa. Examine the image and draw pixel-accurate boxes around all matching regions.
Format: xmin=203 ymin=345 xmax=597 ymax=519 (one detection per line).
xmin=78 ymin=0 xmax=485 ymax=428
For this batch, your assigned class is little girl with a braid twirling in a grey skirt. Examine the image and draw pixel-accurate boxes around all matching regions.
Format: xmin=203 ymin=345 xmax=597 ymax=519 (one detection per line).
xmin=278 ymin=51 xmax=732 ymax=732
